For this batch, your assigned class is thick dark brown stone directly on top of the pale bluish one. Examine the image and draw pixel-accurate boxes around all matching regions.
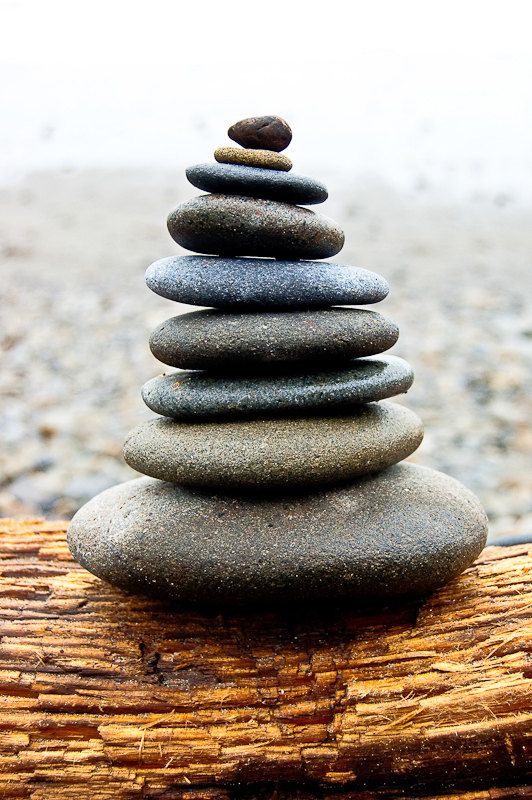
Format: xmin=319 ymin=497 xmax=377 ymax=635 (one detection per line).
xmin=168 ymin=194 xmax=344 ymax=259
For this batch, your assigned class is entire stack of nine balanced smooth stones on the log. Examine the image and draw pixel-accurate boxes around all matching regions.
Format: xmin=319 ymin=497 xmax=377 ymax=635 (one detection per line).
xmin=69 ymin=117 xmax=486 ymax=605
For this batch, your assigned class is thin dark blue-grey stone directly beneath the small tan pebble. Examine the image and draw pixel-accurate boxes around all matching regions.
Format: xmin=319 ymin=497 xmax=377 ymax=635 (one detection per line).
xmin=186 ymin=164 xmax=328 ymax=206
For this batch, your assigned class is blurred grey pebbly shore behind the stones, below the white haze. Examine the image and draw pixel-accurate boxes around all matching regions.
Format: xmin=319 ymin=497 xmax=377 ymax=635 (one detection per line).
xmin=0 ymin=171 xmax=532 ymax=538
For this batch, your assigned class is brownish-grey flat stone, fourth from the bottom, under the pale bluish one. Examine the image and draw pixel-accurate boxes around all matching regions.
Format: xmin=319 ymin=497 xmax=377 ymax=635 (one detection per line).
xmin=150 ymin=308 xmax=399 ymax=370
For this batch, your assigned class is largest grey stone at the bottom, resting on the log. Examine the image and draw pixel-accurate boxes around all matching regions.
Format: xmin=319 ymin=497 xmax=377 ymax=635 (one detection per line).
xmin=68 ymin=464 xmax=487 ymax=607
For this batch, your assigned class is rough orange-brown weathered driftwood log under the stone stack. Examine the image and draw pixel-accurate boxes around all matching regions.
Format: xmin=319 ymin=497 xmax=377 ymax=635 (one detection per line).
xmin=0 ymin=520 xmax=532 ymax=800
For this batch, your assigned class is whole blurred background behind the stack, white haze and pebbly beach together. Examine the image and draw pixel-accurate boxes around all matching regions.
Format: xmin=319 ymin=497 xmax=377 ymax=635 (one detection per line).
xmin=0 ymin=0 xmax=532 ymax=540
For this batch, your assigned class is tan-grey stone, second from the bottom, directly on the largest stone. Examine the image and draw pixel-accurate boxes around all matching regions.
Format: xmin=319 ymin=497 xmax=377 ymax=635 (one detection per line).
xmin=124 ymin=402 xmax=423 ymax=488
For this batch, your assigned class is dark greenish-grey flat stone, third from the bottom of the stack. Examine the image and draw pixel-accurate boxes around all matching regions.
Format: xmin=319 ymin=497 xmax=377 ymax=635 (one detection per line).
xmin=142 ymin=356 xmax=414 ymax=421
